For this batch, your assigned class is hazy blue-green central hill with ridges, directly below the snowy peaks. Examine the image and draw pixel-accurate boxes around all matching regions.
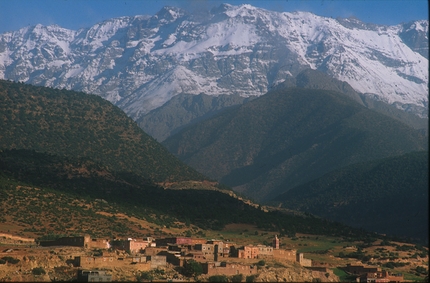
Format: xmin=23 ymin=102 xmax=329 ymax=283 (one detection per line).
xmin=163 ymin=88 xmax=428 ymax=201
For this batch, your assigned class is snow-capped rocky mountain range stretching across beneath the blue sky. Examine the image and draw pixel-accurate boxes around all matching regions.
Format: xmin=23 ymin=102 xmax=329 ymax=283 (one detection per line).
xmin=0 ymin=4 xmax=429 ymax=119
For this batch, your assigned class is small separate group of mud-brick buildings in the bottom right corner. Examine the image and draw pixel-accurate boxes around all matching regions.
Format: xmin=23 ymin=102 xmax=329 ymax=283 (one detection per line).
xmin=344 ymin=264 xmax=403 ymax=283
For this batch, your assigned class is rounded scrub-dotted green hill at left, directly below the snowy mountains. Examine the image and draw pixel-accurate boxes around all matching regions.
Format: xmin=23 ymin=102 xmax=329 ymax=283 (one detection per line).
xmin=0 ymin=81 xmax=205 ymax=182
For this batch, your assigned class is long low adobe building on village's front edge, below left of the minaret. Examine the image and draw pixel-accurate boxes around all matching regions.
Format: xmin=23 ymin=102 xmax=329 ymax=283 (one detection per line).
xmin=202 ymin=262 xmax=257 ymax=276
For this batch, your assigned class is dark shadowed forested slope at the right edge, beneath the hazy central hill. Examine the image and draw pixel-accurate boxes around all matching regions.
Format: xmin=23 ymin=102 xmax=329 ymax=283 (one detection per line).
xmin=273 ymin=151 xmax=429 ymax=243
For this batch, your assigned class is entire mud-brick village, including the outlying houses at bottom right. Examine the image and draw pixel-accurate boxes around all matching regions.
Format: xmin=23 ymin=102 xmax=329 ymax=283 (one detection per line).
xmin=0 ymin=233 xmax=403 ymax=282
